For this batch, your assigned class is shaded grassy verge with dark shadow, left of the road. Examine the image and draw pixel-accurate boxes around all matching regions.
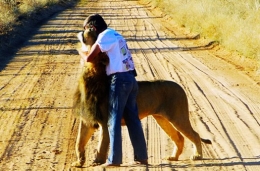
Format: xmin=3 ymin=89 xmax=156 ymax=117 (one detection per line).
xmin=0 ymin=0 xmax=78 ymax=58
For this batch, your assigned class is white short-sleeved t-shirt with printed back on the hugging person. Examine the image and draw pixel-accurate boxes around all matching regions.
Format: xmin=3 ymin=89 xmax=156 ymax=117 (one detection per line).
xmin=96 ymin=28 xmax=135 ymax=75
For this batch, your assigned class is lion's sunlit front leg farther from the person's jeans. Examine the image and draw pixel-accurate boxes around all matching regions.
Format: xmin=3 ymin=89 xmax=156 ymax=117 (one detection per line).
xmin=72 ymin=119 xmax=95 ymax=167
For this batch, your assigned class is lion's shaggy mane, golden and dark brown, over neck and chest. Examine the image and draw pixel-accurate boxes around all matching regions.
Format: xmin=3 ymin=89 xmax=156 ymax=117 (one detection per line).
xmin=73 ymin=31 xmax=109 ymax=125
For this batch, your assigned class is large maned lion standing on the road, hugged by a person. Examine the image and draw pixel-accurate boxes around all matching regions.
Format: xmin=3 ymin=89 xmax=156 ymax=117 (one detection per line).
xmin=72 ymin=30 xmax=211 ymax=167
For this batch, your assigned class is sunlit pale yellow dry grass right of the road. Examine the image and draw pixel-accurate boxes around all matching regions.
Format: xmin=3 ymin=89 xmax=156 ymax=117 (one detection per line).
xmin=140 ymin=0 xmax=260 ymax=61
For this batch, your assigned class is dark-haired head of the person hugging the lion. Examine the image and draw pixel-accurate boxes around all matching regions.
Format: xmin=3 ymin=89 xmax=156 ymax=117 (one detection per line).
xmin=83 ymin=14 xmax=107 ymax=34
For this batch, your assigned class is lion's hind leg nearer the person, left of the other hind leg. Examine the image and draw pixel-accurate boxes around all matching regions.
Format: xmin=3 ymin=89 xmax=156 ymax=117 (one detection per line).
xmin=153 ymin=115 xmax=184 ymax=161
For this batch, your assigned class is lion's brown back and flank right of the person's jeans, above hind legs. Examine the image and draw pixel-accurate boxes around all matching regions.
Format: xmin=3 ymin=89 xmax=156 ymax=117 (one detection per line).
xmin=137 ymin=80 xmax=188 ymax=118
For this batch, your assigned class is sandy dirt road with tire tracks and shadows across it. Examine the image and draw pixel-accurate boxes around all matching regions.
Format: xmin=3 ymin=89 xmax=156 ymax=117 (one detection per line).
xmin=0 ymin=0 xmax=260 ymax=171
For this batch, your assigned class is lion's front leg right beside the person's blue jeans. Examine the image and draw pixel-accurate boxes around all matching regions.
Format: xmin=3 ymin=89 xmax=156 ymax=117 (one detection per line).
xmin=94 ymin=123 xmax=110 ymax=164
